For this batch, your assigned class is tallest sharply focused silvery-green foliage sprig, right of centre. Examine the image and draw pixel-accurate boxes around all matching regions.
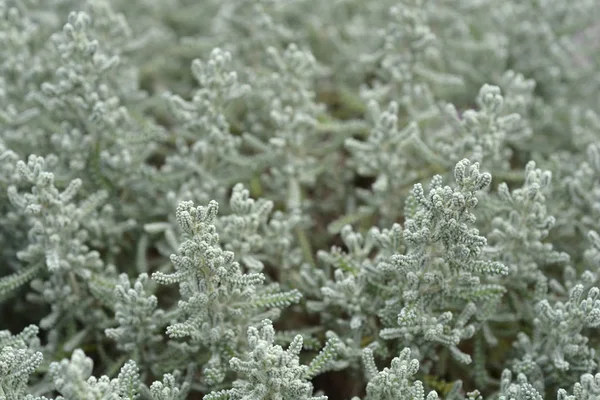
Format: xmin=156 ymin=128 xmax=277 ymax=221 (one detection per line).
xmin=379 ymin=160 xmax=508 ymax=363
